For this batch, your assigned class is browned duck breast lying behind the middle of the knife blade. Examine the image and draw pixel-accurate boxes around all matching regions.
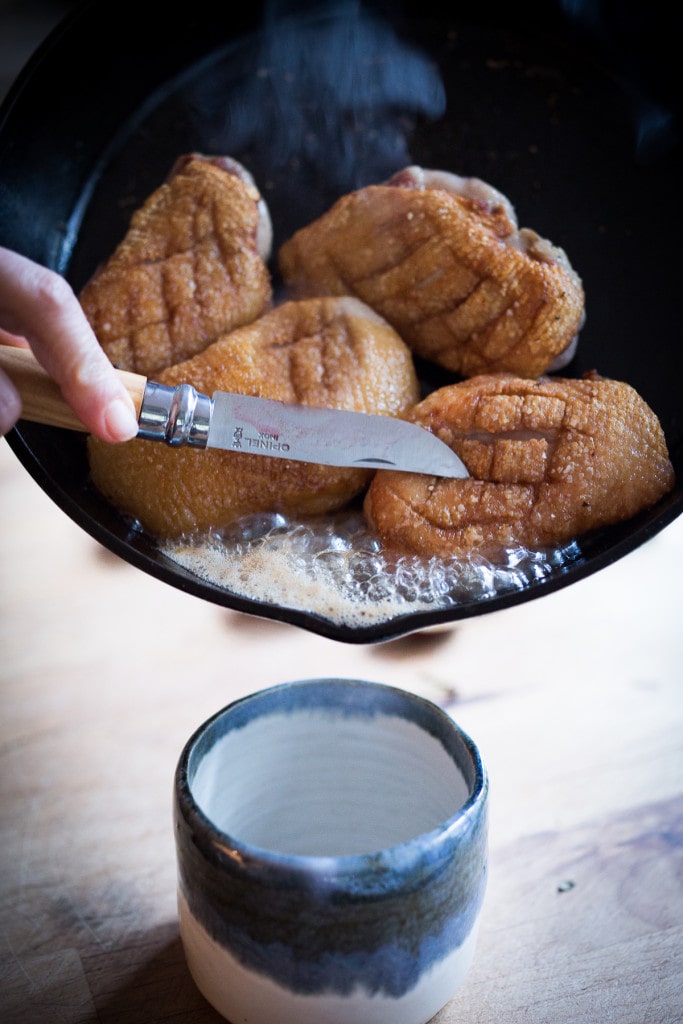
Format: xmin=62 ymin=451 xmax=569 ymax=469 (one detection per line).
xmin=88 ymin=298 xmax=419 ymax=538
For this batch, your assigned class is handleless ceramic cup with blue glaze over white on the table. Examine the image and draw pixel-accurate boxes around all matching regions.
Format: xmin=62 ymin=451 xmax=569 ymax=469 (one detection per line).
xmin=174 ymin=679 xmax=487 ymax=1024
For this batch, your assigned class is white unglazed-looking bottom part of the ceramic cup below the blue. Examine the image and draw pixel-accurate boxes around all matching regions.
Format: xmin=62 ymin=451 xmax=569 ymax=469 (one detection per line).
xmin=178 ymin=891 xmax=478 ymax=1024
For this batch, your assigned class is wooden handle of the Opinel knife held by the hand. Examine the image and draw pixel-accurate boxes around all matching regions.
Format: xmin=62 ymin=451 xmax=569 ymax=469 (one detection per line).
xmin=0 ymin=345 xmax=147 ymax=433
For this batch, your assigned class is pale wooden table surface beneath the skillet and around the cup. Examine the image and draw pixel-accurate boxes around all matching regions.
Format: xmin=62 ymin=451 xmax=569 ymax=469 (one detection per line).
xmin=0 ymin=441 xmax=683 ymax=1024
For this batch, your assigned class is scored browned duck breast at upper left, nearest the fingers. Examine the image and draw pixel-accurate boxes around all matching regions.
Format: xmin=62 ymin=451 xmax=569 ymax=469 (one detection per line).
xmin=79 ymin=155 xmax=271 ymax=376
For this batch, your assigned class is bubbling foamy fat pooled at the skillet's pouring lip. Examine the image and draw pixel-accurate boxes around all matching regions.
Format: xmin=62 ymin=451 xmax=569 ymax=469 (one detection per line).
xmin=162 ymin=511 xmax=580 ymax=628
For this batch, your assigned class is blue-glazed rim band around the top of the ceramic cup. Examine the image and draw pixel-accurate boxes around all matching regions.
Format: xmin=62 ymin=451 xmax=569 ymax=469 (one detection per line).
xmin=174 ymin=677 xmax=488 ymax=890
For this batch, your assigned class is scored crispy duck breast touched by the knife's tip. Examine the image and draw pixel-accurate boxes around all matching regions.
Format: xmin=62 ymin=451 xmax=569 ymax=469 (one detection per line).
xmin=364 ymin=375 xmax=674 ymax=557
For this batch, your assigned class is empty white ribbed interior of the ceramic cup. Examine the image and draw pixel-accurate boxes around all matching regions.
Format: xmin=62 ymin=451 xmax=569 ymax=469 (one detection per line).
xmin=189 ymin=709 xmax=470 ymax=857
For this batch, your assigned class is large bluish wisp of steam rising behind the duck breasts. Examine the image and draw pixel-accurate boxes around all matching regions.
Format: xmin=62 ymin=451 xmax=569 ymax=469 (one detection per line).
xmin=186 ymin=2 xmax=446 ymax=237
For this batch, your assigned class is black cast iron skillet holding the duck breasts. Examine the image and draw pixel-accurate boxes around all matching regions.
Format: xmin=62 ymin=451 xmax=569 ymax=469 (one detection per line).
xmin=0 ymin=0 xmax=683 ymax=642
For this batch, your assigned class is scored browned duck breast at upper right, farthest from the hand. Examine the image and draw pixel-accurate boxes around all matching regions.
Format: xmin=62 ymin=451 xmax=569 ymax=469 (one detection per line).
xmin=279 ymin=168 xmax=584 ymax=377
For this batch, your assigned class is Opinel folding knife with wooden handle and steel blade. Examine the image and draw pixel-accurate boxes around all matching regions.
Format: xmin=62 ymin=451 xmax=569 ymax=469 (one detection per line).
xmin=0 ymin=345 xmax=469 ymax=477
